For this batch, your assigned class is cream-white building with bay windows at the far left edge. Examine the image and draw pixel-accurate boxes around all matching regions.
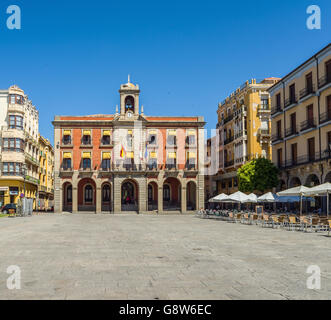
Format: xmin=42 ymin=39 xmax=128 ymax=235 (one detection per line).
xmin=0 ymin=86 xmax=39 ymax=208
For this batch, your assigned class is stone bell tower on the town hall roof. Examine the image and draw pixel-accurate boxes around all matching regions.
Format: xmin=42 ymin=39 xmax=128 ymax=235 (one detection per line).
xmin=119 ymin=75 xmax=140 ymax=120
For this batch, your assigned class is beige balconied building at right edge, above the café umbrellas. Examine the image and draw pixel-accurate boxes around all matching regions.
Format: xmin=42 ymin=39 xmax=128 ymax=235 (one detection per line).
xmin=269 ymin=44 xmax=331 ymax=189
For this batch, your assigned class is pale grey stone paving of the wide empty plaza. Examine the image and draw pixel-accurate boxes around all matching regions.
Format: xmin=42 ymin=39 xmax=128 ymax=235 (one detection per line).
xmin=0 ymin=214 xmax=331 ymax=299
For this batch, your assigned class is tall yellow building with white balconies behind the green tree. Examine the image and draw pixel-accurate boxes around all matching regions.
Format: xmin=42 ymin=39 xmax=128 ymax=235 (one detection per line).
xmin=214 ymin=78 xmax=279 ymax=194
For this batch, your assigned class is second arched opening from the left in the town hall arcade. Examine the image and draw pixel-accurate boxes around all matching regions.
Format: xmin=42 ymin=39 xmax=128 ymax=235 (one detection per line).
xmin=78 ymin=178 xmax=96 ymax=211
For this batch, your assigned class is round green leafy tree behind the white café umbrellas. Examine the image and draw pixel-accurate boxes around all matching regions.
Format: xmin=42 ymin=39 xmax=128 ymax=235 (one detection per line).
xmin=238 ymin=158 xmax=279 ymax=192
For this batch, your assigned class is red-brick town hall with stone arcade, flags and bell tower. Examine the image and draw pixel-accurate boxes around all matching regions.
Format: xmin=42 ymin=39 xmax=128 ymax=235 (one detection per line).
xmin=53 ymin=79 xmax=205 ymax=213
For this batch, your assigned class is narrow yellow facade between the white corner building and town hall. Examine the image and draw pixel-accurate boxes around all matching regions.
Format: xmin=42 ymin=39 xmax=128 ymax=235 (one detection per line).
xmin=38 ymin=135 xmax=54 ymax=211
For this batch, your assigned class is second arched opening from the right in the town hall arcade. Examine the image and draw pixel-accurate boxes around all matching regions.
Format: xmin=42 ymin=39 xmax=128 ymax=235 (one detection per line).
xmin=163 ymin=177 xmax=181 ymax=211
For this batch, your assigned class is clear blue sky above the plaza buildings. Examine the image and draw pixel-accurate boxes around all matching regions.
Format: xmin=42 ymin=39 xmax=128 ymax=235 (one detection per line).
xmin=0 ymin=0 xmax=331 ymax=141
